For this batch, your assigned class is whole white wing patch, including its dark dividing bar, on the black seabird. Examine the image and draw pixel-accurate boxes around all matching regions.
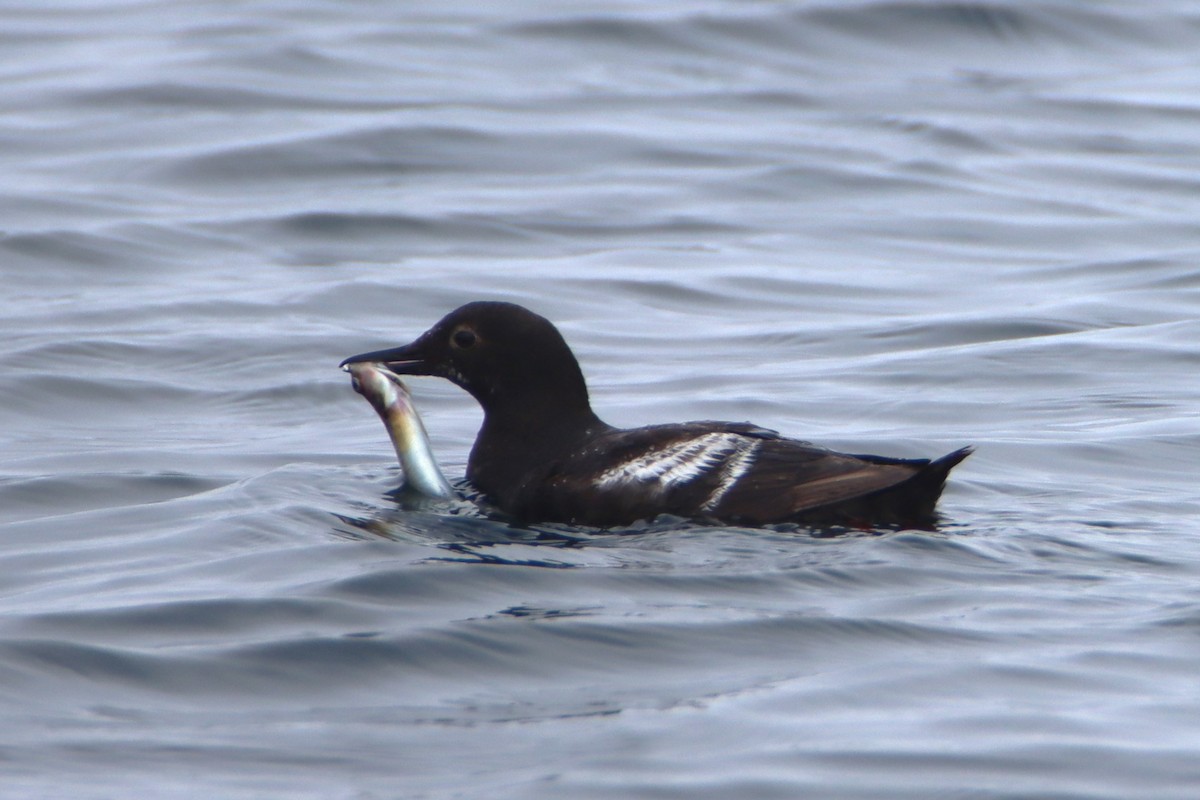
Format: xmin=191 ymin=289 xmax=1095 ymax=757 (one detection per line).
xmin=595 ymin=432 xmax=761 ymax=511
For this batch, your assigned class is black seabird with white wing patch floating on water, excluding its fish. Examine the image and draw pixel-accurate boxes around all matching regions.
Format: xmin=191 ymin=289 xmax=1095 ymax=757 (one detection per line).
xmin=342 ymin=302 xmax=971 ymax=528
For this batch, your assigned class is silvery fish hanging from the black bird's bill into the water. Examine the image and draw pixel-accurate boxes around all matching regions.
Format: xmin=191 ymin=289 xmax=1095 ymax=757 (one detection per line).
xmin=342 ymin=362 xmax=455 ymax=499
